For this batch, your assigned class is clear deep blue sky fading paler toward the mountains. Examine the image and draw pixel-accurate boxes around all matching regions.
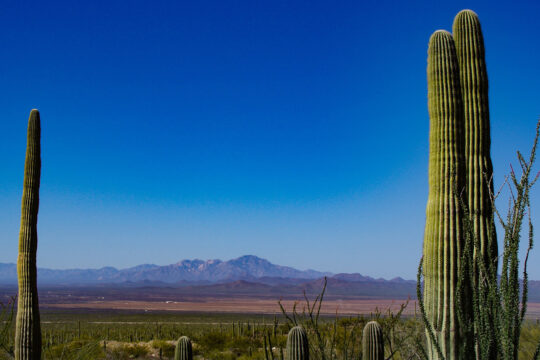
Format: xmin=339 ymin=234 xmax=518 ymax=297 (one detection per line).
xmin=0 ymin=1 xmax=540 ymax=279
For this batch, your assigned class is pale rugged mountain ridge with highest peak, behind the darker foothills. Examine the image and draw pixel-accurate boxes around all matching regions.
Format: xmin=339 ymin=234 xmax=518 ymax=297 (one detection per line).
xmin=0 ymin=255 xmax=334 ymax=285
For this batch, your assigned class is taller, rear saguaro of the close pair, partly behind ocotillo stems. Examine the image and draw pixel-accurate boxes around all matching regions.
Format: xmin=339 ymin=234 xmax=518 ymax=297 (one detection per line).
xmin=453 ymin=10 xmax=498 ymax=359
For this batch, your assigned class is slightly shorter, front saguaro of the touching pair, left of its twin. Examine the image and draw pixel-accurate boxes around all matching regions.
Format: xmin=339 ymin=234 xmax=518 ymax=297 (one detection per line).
xmin=423 ymin=30 xmax=467 ymax=359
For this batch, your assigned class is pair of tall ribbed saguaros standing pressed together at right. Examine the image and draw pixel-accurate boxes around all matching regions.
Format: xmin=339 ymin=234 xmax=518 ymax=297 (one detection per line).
xmin=423 ymin=10 xmax=497 ymax=359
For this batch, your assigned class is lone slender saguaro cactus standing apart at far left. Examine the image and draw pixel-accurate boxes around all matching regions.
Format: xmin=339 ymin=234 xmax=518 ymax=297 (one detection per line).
xmin=14 ymin=109 xmax=41 ymax=360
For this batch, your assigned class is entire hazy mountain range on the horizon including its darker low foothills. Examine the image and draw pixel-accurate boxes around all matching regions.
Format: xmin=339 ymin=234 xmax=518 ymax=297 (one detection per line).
xmin=4 ymin=255 xmax=540 ymax=302
